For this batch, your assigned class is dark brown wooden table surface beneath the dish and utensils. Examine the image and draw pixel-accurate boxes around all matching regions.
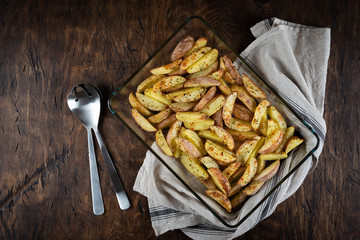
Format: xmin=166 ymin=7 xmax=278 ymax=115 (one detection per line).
xmin=0 ymin=0 xmax=360 ymax=239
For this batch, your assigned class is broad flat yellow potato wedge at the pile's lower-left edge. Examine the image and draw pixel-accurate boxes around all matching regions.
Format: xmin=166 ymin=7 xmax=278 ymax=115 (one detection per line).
xmin=180 ymin=152 xmax=210 ymax=182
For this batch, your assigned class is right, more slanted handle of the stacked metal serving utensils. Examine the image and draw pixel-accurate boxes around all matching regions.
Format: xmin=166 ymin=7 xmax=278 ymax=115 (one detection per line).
xmin=93 ymin=128 xmax=130 ymax=210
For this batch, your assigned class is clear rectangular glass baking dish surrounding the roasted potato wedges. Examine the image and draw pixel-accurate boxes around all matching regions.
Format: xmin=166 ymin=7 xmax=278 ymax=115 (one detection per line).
xmin=108 ymin=16 xmax=319 ymax=227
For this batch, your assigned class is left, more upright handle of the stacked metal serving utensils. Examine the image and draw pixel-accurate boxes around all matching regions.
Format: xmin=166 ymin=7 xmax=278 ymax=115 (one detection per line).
xmin=86 ymin=128 xmax=104 ymax=215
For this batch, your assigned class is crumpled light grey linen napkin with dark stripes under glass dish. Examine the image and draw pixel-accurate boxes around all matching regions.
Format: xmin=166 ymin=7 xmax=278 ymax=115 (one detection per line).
xmin=133 ymin=18 xmax=330 ymax=239
